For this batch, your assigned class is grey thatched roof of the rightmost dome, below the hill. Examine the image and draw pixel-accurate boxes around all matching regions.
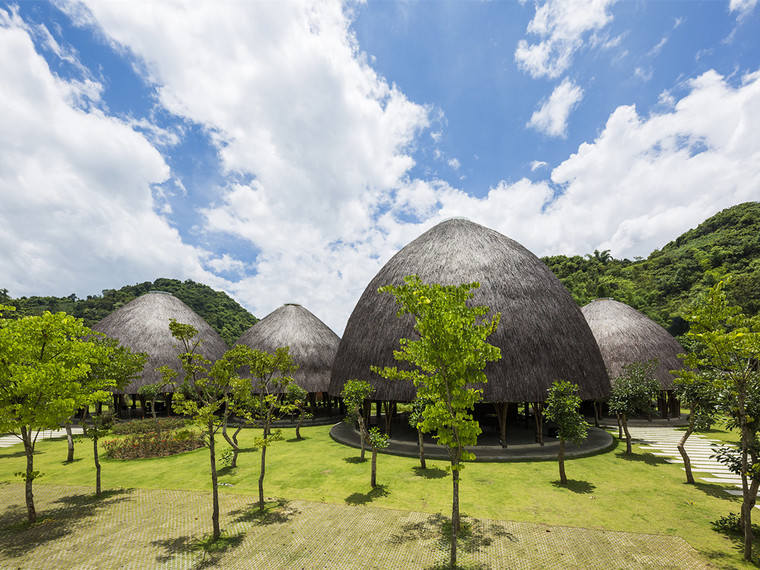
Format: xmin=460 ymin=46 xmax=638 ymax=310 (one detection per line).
xmin=581 ymin=299 xmax=686 ymax=390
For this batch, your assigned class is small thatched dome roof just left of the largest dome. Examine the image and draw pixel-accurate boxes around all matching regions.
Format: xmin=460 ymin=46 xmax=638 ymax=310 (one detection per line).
xmin=235 ymin=304 xmax=340 ymax=392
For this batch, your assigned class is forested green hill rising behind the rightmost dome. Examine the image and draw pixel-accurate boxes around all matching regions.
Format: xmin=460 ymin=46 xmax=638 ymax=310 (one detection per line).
xmin=543 ymin=202 xmax=760 ymax=335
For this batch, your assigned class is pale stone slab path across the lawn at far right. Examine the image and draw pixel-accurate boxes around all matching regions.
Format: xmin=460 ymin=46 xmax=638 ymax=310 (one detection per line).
xmin=628 ymin=427 xmax=748 ymax=502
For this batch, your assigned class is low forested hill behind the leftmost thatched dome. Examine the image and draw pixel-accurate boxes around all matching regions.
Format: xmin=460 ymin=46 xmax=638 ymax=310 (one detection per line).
xmin=0 ymin=278 xmax=258 ymax=346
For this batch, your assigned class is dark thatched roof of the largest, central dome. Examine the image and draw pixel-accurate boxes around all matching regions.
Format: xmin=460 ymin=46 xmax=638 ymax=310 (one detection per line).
xmin=330 ymin=219 xmax=609 ymax=402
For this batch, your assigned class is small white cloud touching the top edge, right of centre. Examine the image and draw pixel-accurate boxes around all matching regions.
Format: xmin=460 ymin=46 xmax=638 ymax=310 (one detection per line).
xmin=515 ymin=0 xmax=619 ymax=79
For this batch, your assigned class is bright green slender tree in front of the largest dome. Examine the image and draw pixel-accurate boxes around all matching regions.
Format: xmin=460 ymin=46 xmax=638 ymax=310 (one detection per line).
xmin=373 ymin=275 xmax=501 ymax=568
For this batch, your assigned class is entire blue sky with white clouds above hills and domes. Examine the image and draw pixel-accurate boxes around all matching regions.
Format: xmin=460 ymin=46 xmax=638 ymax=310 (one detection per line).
xmin=0 ymin=0 xmax=760 ymax=334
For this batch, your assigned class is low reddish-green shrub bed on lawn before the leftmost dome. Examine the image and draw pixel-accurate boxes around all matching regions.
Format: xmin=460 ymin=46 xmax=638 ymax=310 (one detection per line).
xmin=103 ymin=430 xmax=204 ymax=459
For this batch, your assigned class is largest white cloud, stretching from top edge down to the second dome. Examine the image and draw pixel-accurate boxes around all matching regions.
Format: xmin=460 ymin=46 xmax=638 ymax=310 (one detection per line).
xmin=61 ymin=1 xmax=430 ymax=330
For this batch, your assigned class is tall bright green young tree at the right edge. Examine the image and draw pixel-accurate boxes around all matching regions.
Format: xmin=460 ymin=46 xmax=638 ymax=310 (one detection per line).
xmin=683 ymin=281 xmax=760 ymax=560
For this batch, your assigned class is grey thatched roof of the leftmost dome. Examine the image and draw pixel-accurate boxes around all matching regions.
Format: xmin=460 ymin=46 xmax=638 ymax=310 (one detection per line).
xmin=92 ymin=291 xmax=227 ymax=394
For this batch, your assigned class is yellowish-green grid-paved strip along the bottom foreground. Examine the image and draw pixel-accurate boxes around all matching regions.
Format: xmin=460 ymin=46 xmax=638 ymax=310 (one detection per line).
xmin=0 ymin=483 xmax=709 ymax=570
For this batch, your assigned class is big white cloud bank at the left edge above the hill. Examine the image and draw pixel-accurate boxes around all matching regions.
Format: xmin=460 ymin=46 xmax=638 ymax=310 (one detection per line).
xmin=0 ymin=9 xmax=220 ymax=295
